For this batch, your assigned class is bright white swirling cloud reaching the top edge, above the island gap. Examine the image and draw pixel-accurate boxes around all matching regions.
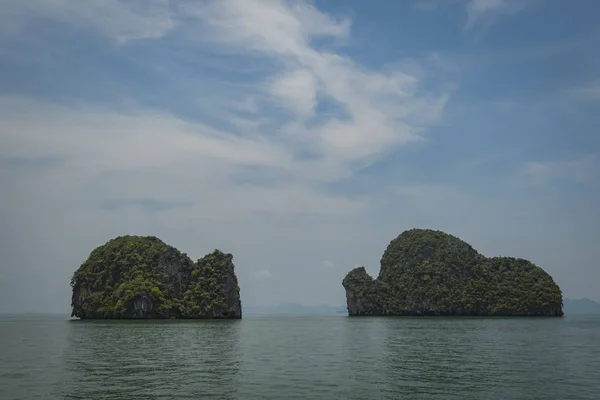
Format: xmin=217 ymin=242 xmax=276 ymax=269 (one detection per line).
xmin=178 ymin=0 xmax=447 ymax=175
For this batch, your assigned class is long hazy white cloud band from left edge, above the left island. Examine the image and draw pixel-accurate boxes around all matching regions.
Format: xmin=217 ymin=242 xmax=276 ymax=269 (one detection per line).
xmin=0 ymin=98 xmax=291 ymax=170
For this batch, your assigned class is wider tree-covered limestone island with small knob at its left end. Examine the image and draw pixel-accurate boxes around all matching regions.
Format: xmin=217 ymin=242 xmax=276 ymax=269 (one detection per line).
xmin=342 ymin=229 xmax=563 ymax=317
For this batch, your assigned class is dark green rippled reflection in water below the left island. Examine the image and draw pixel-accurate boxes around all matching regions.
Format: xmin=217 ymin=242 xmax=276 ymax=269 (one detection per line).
xmin=61 ymin=320 xmax=240 ymax=399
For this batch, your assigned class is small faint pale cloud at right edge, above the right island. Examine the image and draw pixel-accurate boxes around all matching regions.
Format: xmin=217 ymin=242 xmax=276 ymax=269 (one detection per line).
xmin=523 ymin=155 xmax=598 ymax=188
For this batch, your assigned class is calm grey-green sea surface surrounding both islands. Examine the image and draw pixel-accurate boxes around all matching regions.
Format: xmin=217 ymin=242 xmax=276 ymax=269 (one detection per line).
xmin=0 ymin=314 xmax=600 ymax=400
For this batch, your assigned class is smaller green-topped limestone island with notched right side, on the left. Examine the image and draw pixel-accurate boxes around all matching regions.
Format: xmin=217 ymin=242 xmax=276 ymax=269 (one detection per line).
xmin=71 ymin=236 xmax=242 ymax=319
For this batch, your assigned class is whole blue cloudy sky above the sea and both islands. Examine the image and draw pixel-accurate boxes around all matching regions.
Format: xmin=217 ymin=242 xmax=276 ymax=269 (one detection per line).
xmin=0 ymin=0 xmax=600 ymax=312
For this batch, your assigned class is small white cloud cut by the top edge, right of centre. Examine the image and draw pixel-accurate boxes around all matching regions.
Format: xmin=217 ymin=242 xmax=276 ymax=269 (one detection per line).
xmin=465 ymin=0 xmax=533 ymax=30
